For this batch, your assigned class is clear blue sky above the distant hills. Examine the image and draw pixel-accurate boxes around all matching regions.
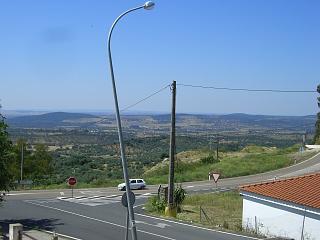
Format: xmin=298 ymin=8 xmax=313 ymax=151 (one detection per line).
xmin=0 ymin=0 xmax=320 ymax=115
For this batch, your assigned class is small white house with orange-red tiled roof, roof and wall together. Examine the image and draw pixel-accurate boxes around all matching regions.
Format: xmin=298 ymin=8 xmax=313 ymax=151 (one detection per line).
xmin=240 ymin=173 xmax=320 ymax=240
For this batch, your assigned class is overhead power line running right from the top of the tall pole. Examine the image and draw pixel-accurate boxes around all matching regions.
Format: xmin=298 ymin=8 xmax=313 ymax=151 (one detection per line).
xmin=177 ymin=83 xmax=317 ymax=93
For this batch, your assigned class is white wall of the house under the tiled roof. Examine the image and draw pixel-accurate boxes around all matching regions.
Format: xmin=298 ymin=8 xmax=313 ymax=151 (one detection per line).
xmin=242 ymin=195 xmax=320 ymax=240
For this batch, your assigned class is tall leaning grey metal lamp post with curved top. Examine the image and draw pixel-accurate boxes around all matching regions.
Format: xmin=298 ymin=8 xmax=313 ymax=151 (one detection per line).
xmin=108 ymin=1 xmax=155 ymax=240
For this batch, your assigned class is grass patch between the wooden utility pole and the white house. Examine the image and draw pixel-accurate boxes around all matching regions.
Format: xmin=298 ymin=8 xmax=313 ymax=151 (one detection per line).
xmin=145 ymin=191 xmax=242 ymax=232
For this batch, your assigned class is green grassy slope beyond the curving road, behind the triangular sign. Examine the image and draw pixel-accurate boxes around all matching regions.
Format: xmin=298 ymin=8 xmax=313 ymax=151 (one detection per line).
xmin=144 ymin=144 xmax=315 ymax=184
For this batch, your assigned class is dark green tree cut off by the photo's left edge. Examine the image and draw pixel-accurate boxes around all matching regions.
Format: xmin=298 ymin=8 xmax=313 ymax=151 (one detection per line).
xmin=0 ymin=111 xmax=13 ymax=191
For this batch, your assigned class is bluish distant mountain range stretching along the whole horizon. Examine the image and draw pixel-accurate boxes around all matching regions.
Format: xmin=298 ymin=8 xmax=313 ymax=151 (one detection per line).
xmin=6 ymin=112 xmax=316 ymax=132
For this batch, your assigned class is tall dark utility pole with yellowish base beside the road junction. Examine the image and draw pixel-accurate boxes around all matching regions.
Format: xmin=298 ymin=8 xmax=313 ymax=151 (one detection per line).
xmin=165 ymin=81 xmax=177 ymax=217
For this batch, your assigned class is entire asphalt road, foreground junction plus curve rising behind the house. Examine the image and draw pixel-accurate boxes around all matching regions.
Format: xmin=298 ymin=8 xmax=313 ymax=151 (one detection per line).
xmin=0 ymin=151 xmax=320 ymax=240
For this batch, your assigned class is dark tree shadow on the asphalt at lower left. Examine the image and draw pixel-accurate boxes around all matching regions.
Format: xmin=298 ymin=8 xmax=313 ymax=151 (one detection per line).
xmin=0 ymin=218 xmax=63 ymax=240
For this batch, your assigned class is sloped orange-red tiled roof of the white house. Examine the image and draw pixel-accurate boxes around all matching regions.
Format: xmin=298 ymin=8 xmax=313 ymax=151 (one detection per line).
xmin=240 ymin=173 xmax=320 ymax=209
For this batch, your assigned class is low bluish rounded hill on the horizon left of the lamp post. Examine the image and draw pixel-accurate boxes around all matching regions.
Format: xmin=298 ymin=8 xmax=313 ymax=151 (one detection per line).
xmin=7 ymin=112 xmax=98 ymax=128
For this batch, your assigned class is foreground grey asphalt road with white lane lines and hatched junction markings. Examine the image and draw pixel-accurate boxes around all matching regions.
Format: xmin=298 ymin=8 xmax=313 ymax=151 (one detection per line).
xmin=0 ymin=191 xmax=254 ymax=240
